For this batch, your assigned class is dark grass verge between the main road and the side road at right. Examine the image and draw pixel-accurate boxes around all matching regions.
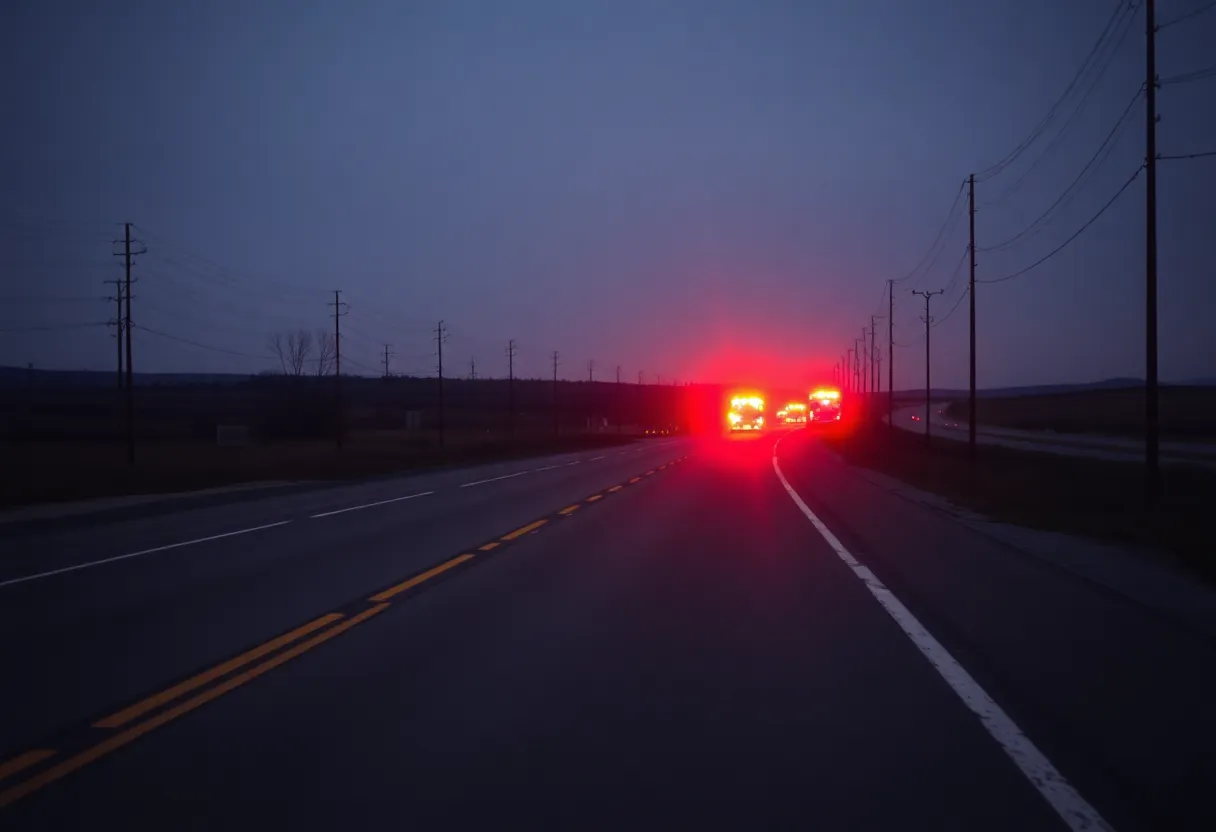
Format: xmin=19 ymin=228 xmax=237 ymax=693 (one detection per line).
xmin=824 ymin=425 xmax=1216 ymax=581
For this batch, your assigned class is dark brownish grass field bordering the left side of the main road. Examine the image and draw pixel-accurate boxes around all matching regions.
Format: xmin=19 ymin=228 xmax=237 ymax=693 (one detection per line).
xmin=0 ymin=431 xmax=634 ymax=506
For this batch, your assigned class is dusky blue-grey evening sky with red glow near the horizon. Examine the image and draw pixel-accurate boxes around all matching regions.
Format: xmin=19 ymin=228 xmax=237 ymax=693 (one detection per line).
xmin=0 ymin=0 xmax=1216 ymax=386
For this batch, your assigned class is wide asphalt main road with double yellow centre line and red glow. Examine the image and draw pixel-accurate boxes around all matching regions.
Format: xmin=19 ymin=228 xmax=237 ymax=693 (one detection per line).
xmin=0 ymin=431 xmax=1216 ymax=830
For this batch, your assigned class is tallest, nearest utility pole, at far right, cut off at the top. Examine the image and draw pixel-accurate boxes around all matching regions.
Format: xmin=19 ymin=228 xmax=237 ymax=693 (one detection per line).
xmin=1144 ymin=0 xmax=1160 ymax=506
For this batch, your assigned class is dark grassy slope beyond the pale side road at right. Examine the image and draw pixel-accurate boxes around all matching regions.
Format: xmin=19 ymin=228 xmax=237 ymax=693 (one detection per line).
xmin=947 ymin=387 xmax=1216 ymax=442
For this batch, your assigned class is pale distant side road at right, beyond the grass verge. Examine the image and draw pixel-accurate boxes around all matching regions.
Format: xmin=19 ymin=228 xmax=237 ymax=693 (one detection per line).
xmin=884 ymin=401 xmax=1216 ymax=468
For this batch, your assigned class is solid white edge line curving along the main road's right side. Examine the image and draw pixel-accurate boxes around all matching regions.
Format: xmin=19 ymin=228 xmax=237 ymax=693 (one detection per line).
xmin=772 ymin=434 xmax=1111 ymax=831
